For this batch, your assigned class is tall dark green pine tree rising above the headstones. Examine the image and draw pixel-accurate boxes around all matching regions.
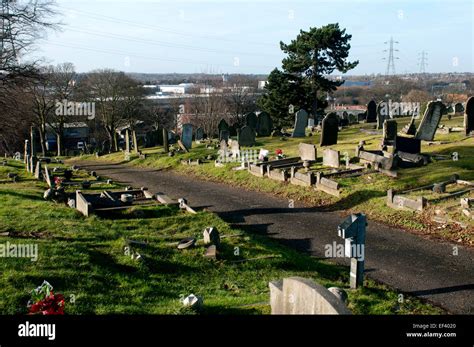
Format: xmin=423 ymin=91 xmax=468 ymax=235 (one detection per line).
xmin=258 ymin=23 xmax=359 ymax=126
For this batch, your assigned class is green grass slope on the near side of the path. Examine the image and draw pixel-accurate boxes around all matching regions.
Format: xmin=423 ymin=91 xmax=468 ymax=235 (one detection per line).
xmin=0 ymin=161 xmax=443 ymax=314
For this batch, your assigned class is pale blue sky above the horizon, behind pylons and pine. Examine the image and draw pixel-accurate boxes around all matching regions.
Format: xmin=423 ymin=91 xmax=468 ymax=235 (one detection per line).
xmin=31 ymin=0 xmax=474 ymax=75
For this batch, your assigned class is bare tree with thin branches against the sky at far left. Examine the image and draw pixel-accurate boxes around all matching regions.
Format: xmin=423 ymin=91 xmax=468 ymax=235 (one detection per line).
xmin=0 ymin=0 xmax=59 ymax=154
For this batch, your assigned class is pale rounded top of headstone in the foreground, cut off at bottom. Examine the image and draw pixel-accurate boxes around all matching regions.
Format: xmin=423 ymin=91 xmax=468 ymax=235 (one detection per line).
xmin=269 ymin=277 xmax=351 ymax=315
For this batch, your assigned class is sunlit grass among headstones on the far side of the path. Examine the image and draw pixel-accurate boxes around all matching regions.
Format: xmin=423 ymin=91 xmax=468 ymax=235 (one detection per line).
xmin=75 ymin=117 xmax=474 ymax=246
